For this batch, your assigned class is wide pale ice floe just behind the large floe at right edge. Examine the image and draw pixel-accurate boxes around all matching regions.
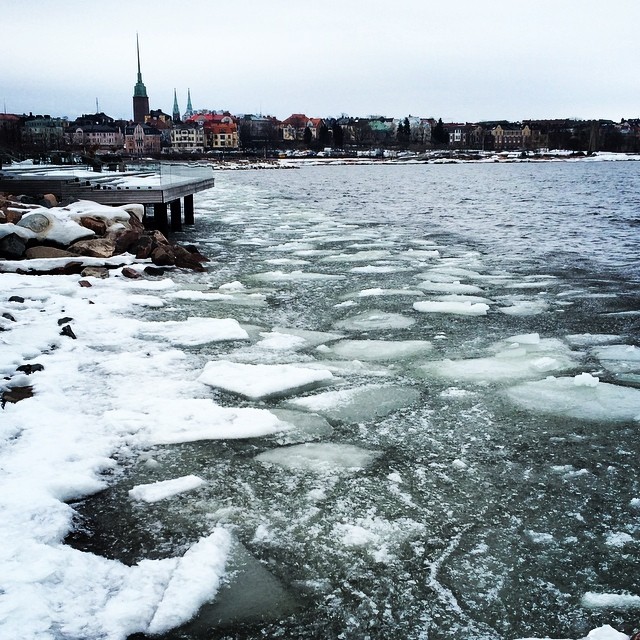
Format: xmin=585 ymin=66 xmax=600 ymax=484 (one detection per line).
xmin=416 ymin=336 xmax=577 ymax=383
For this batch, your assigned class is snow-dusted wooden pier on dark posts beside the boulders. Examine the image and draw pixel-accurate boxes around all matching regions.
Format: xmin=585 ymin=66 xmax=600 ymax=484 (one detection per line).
xmin=0 ymin=164 xmax=215 ymax=231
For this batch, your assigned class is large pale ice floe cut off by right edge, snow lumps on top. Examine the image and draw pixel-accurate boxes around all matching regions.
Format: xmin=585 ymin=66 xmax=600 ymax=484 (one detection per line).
xmin=505 ymin=377 xmax=640 ymax=422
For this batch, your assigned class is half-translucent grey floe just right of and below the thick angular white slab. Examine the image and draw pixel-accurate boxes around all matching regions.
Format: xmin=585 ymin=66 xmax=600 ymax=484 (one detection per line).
xmin=286 ymin=384 xmax=420 ymax=422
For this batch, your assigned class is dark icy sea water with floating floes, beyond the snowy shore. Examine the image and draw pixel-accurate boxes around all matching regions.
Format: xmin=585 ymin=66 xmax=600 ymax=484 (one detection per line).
xmin=70 ymin=161 xmax=640 ymax=640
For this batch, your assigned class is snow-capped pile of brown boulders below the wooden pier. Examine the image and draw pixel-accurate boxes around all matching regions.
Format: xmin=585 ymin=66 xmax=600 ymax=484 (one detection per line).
xmin=0 ymin=194 xmax=208 ymax=277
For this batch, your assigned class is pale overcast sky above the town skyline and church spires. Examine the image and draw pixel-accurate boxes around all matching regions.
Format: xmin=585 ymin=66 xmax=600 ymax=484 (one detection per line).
xmin=0 ymin=0 xmax=640 ymax=122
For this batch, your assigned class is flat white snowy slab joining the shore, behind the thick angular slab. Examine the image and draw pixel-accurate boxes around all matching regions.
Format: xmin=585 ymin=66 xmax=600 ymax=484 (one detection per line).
xmin=138 ymin=317 xmax=249 ymax=346
